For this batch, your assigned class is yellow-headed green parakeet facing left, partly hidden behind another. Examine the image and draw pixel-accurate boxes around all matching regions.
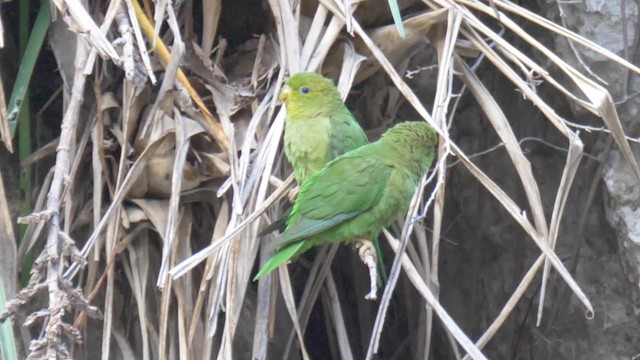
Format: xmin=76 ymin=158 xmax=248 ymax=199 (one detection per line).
xmin=280 ymin=72 xmax=368 ymax=186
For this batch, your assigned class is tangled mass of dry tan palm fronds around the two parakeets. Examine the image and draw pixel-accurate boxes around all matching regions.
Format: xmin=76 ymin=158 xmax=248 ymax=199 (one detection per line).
xmin=0 ymin=0 xmax=640 ymax=359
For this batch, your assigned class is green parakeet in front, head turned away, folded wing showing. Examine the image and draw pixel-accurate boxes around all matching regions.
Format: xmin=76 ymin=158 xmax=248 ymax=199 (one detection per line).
xmin=255 ymin=122 xmax=438 ymax=299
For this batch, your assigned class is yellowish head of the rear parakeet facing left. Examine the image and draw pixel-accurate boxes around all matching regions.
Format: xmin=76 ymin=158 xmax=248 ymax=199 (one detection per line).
xmin=279 ymin=72 xmax=344 ymax=117
